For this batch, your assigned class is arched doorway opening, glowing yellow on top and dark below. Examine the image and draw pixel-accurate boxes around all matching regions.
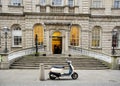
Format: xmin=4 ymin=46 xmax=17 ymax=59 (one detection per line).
xmin=52 ymin=32 xmax=62 ymax=54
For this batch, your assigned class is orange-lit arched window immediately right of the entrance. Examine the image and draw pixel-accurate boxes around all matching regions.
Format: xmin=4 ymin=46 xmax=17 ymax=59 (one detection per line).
xmin=70 ymin=26 xmax=80 ymax=46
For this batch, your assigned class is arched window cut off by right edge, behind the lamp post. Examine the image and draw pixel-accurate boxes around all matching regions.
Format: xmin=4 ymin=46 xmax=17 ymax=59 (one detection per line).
xmin=112 ymin=27 xmax=120 ymax=48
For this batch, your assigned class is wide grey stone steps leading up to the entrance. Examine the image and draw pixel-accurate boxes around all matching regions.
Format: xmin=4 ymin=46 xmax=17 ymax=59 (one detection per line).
xmin=10 ymin=56 xmax=109 ymax=70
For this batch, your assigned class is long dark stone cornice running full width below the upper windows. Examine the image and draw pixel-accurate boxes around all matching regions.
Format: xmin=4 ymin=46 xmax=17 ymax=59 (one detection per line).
xmin=0 ymin=12 xmax=120 ymax=19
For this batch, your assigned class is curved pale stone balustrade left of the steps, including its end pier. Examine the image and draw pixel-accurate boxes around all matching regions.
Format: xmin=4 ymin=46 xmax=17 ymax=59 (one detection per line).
xmin=0 ymin=46 xmax=45 ymax=69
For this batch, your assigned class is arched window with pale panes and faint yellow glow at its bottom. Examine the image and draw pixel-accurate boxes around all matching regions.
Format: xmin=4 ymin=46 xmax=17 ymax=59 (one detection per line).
xmin=92 ymin=26 xmax=101 ymax=47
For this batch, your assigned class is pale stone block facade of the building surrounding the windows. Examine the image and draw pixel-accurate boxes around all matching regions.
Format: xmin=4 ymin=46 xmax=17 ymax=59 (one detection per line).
xmin=0 ymin=0 xmax=120 ymax=54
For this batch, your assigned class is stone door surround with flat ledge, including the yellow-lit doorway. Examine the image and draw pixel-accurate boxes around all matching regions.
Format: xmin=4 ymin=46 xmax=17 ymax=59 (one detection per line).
xmin=45 ymin=23 xmax=70 ymax=54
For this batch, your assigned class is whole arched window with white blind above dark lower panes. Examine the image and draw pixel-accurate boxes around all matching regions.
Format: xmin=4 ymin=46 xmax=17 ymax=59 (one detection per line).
xmin=12 ymin=25 xmax=22 ymax=47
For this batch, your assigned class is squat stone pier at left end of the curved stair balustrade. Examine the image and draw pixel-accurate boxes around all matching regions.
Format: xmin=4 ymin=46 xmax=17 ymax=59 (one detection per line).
xmin=0 ymin=53 xmax=9 ymax=69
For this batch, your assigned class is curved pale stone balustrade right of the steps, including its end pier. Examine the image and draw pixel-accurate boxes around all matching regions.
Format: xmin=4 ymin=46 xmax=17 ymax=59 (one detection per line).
xmin=69 ymin=46 xmax=120 ymax=69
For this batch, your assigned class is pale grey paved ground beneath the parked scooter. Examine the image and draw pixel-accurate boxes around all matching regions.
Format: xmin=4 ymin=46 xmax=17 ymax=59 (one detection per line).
xmin=0 ymin=70 xmax=120 ymax=86
